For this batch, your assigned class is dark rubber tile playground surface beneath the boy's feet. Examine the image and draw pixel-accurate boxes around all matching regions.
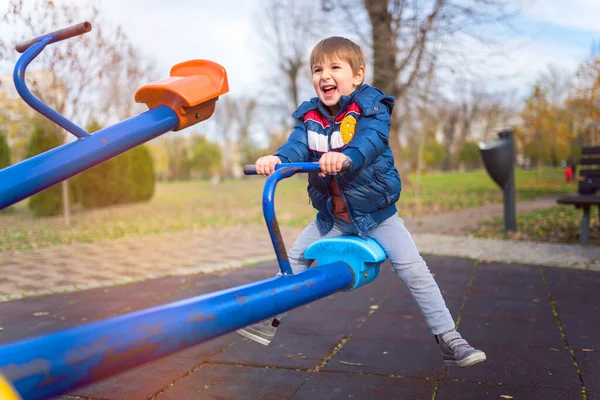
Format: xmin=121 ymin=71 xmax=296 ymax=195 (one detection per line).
xmin=0 ymin=256 xmax=600 ymax=400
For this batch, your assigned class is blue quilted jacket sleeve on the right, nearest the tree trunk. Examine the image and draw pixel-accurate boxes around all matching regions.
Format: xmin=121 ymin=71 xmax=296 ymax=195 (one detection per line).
xmin=342 ymin=102 xmax=391 ymax=171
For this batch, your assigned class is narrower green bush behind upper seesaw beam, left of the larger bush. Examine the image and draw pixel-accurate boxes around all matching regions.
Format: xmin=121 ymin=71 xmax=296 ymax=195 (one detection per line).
xmin=26 ymin=123 xmax=62 ymax=217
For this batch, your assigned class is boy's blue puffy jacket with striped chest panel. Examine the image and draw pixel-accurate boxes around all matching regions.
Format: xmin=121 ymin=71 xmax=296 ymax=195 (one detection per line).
xmin=275 ymin=84 xmax=402 ymax=236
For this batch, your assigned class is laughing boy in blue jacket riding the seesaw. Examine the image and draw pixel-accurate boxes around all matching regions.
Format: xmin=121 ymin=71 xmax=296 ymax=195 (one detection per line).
xmin=237 ymin=37 xmax=485 ymax=367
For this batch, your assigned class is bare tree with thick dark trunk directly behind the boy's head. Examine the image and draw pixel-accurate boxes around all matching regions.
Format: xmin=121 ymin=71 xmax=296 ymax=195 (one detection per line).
xmin=323 ymin=0 xmax=527 ymax=173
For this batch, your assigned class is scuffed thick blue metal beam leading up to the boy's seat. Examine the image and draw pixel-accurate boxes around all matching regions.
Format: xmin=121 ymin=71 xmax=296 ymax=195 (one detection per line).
xmin=0 ymin=261 xmax=354 ymax=400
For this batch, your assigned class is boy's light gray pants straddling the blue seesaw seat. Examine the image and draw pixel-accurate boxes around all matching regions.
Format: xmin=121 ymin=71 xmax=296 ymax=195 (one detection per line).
xmin=279 ymin=214 xmax=455 ymax=335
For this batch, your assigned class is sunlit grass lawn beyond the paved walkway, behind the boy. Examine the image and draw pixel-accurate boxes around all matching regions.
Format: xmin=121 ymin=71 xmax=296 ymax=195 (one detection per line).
xmin=0 ymin=169 xmax=574 ymax=252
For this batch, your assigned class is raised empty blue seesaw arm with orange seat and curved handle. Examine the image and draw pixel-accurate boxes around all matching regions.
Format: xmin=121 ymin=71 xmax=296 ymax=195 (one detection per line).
xmin=0 ymin=22 xmax=229 ymax=210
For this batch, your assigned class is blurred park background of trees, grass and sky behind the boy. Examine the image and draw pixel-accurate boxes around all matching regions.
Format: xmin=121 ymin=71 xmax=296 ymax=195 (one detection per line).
xmin=0 ymin=0 xmax=600 ymax=247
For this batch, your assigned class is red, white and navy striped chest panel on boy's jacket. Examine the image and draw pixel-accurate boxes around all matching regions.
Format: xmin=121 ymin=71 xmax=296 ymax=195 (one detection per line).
xmin=303 ymin=102 xmax=361 ymax=153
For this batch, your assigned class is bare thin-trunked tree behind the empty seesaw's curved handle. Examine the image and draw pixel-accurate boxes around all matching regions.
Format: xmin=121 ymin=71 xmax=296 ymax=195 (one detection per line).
xmin=0 ymin=0 xmax=157 ymax=225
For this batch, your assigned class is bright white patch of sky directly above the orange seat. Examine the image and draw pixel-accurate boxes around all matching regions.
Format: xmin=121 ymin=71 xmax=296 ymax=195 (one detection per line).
xmin=100 ymin=0 xmax=261 ymax=97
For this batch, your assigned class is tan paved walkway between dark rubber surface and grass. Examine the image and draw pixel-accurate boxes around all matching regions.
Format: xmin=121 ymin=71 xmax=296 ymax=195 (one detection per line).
xmin=0 ymin=199 xmax=600 ymax=301
